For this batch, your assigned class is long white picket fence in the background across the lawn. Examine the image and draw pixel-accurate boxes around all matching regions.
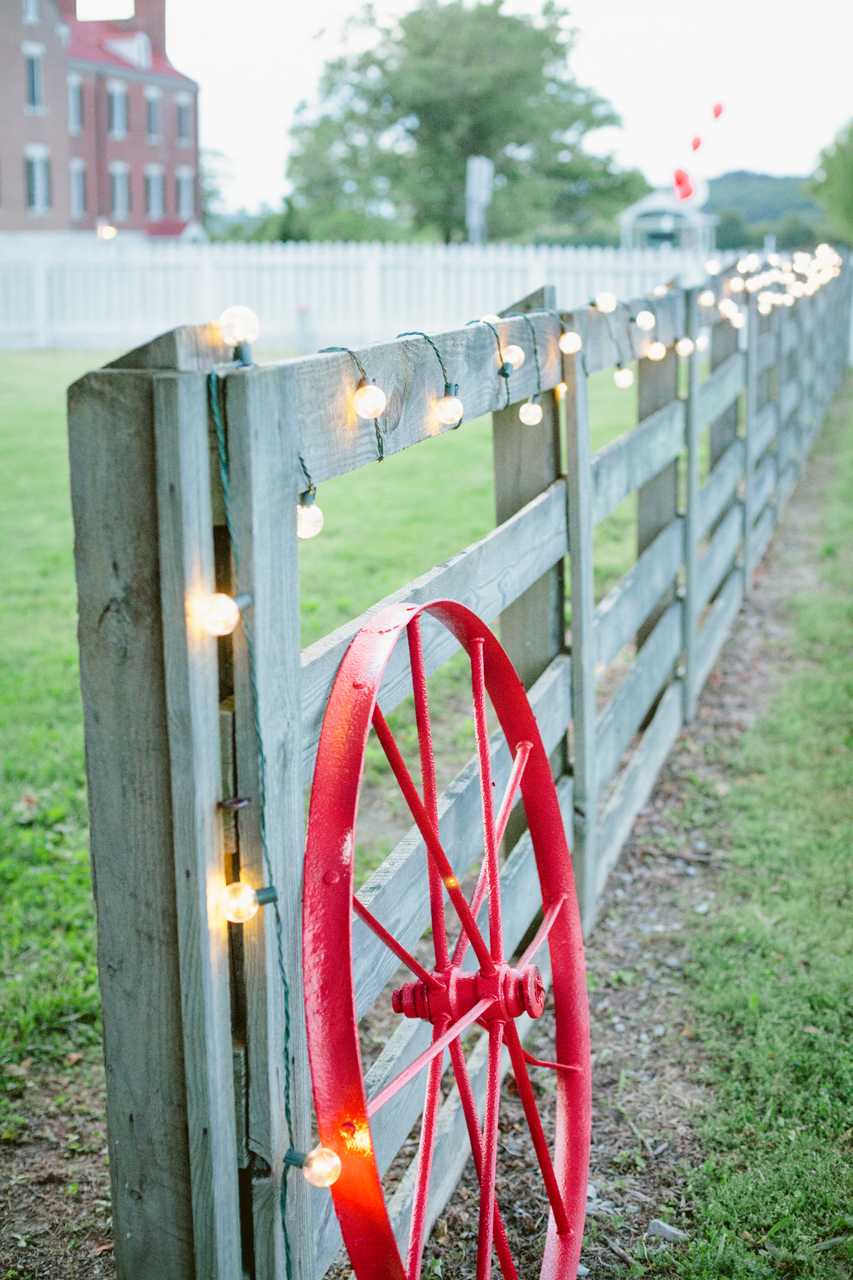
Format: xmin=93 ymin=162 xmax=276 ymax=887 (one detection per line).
xmin=0 ymin=232 xmax=731 ymax=353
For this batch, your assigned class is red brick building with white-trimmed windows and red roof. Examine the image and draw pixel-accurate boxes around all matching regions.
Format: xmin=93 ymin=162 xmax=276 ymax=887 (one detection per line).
xmin=0 ymin=0 xmax=200 ymax=234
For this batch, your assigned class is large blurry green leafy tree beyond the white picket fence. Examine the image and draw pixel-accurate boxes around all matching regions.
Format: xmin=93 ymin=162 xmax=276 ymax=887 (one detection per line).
xmin=288 ymin=0 xmax=648 ymax=241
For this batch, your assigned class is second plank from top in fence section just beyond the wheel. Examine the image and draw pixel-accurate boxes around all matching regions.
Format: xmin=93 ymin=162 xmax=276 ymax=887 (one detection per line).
xmin=592 ymin=401 xmax=685 ymax=525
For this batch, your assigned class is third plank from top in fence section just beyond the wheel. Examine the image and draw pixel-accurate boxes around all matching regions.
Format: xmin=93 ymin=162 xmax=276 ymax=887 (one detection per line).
xmin=596 ymin=516 xmax=684 ymax=671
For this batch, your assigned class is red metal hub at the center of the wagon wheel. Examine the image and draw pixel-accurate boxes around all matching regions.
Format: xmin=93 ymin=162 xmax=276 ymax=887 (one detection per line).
xmin=391 ymin=961 xmax=546 ymax=1023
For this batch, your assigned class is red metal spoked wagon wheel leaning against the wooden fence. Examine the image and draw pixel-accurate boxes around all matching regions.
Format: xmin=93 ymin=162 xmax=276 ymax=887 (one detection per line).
xmin=304 ymin=600 xmax=590 ymax=1280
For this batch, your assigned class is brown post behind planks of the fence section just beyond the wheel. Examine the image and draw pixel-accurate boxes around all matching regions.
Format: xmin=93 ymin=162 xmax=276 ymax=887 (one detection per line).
xmin=637 ymin=347 xmax=684 ymax=649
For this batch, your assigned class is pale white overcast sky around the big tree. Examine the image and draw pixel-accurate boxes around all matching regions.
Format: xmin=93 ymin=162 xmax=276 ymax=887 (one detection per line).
xmin=153 ymin=0 xmax=853 ymax=210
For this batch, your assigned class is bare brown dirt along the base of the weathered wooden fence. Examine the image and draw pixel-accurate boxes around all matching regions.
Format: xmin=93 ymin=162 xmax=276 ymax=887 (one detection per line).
xmin=0 ymin=417 xmax=831 ymax=1280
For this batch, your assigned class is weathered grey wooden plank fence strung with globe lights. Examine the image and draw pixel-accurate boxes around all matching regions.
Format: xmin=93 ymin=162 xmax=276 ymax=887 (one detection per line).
xmin=69 ymin=259 xmax=850 ymax=1280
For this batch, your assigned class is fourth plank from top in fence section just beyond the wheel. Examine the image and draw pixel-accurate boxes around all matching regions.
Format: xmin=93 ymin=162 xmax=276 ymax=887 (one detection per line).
xmin=596 ymin=600 xmax=683 ymax=788
